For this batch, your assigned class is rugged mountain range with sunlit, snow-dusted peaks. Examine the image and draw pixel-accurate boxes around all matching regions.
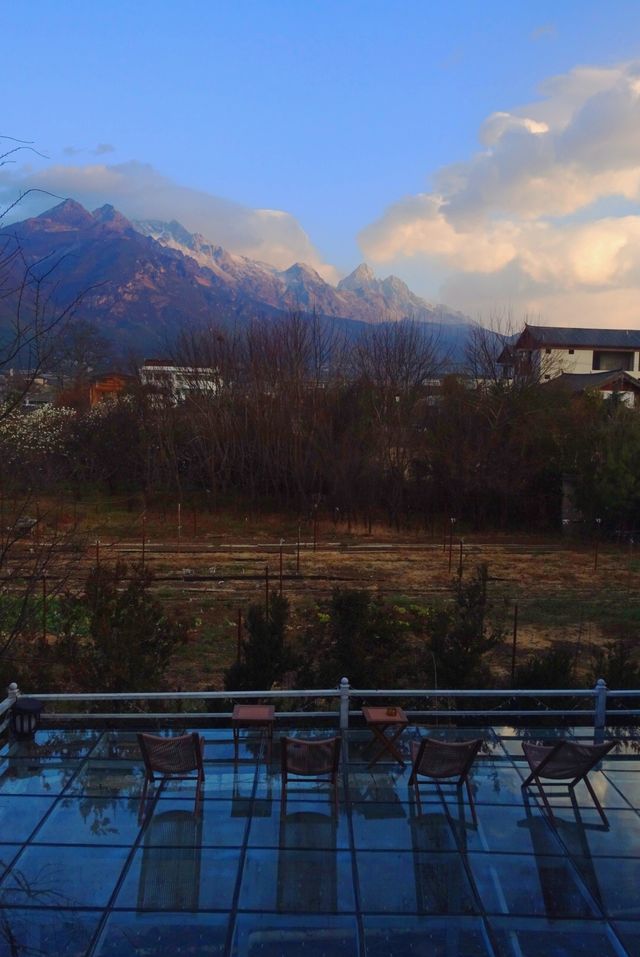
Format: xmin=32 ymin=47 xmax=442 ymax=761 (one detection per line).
xmin=0 ymin=199 xmax=468 ymax=354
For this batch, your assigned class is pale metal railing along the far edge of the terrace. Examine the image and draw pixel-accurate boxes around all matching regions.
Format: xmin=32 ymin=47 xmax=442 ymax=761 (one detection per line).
xmin=0 ymin=678 xmax=640 ymax=731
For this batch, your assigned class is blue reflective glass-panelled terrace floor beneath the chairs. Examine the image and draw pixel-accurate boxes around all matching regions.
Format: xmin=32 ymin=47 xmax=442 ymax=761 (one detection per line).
xmin=0 ymin=727 xmax=640 ymax=957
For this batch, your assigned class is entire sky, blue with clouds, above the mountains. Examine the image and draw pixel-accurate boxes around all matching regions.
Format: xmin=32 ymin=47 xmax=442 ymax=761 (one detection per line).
xmin=0 ymin=0 xmax=640 ymax=324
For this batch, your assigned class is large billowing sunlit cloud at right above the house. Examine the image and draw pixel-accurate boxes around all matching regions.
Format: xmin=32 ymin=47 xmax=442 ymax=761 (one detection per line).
xmin=360 ymin=62 xmax=640 ymax=325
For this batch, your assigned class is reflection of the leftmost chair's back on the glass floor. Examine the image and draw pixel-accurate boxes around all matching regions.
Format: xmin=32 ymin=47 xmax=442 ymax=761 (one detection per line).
xmin=137 ymin=811 xmax=204 ymax=911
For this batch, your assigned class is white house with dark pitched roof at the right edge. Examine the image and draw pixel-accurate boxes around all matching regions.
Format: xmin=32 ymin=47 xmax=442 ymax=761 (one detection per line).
xmin=498 ymin=325 xmax=640 ymax=387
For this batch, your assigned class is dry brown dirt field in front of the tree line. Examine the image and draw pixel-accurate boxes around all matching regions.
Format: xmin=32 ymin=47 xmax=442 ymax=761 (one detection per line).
xmin=13 ymin=503 xmax=640 ymax=690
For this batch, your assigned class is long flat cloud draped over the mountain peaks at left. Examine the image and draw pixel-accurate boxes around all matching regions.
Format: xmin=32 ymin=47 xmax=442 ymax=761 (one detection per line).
xmin=0 ymin=159 xmax=336 ymax=282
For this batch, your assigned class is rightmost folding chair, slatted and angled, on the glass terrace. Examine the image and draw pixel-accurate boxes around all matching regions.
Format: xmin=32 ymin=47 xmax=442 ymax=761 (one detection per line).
xmin=522 ymin=740 xmax=619 ymax=827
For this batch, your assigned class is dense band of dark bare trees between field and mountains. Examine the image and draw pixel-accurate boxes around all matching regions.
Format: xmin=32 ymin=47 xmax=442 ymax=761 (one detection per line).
xmin=0 ymin=315 xmax=640 ymax=530
